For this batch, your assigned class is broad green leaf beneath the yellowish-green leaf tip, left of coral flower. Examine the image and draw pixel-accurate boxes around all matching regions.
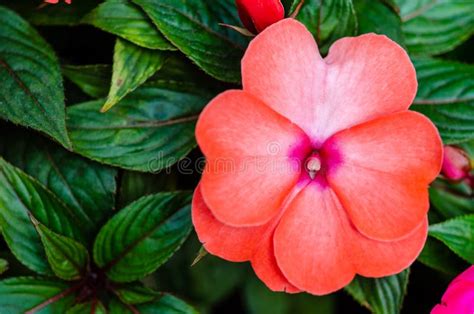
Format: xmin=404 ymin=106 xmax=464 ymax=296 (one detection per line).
xmin=68 ymin=63 xmax=215 ymax=172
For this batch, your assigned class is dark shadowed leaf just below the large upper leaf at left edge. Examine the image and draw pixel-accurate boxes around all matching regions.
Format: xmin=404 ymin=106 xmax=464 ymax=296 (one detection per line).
xmin=0 ymin=128 xmax=117 ymax=240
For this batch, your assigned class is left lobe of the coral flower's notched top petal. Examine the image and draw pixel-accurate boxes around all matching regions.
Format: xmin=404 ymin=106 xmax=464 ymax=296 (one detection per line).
xmin=242 ymin=19 xmax=325 ymax=140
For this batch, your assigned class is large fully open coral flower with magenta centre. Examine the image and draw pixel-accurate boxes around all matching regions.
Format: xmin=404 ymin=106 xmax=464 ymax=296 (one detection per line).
xmin=193 ymin=19 xmax=442 ymax=295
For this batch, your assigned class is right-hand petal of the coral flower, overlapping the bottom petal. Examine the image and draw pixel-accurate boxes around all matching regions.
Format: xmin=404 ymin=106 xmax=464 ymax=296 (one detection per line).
xmin=323 ymin=111 xmax=442 ymax=240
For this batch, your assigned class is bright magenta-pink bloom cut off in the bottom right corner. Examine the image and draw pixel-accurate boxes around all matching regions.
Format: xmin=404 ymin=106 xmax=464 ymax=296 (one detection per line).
xmin=431 ymin=266 xmax=474 ymax=314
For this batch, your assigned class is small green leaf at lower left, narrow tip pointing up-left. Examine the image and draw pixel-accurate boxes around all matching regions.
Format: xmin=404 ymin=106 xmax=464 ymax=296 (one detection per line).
xmin=31 ymin=217 xmax=89 ymax=280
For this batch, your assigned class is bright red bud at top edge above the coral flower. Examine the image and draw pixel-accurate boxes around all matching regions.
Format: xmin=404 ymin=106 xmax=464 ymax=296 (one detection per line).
xmin=235 ymin=0 xmax=285 ymax=34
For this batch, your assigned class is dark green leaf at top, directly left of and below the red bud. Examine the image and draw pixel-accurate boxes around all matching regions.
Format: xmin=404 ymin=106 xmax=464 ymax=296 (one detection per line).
xmin=133 ymin=0 xmax=247 ymax=83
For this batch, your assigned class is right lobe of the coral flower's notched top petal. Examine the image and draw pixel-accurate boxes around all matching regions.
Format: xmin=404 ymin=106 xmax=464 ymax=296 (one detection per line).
xmin=314 ymin=34 xmax=418 ymax=141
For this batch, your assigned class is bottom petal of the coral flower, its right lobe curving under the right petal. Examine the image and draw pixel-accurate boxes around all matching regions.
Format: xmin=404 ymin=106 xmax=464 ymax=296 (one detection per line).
xmin=274 ymin=184 xmax=428 ymax=295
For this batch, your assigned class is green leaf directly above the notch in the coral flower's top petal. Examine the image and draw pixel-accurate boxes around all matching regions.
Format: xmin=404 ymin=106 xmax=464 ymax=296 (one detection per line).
xmin=296 ymin=0 xmax=357 ymax=53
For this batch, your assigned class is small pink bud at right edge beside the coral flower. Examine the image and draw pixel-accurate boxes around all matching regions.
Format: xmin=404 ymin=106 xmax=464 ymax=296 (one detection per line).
xmin=442 ymin=146 xmax=471 ymax=180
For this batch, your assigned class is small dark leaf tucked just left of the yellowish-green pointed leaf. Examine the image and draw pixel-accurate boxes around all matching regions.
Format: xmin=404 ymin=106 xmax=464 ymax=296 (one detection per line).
xmin=62 ymin=64 xmax=112 ymax=98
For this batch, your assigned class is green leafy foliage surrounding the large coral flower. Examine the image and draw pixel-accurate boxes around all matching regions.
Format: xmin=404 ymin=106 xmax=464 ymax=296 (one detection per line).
xmin=0 ymin=0 xmax=474 ymax=314
